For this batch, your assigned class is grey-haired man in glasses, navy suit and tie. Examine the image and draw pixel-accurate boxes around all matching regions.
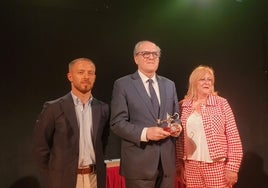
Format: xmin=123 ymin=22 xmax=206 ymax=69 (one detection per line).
xmin=110 ymin=41 xmax=181 ymax=188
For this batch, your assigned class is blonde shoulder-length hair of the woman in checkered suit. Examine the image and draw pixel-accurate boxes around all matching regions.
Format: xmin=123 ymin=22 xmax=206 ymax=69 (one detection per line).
xmin=184 ymin=65 xmax=217 ymax=99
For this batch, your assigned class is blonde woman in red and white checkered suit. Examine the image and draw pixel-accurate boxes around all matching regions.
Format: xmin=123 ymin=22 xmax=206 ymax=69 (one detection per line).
xmin=176 ymin=66 xmax=243 ymax=188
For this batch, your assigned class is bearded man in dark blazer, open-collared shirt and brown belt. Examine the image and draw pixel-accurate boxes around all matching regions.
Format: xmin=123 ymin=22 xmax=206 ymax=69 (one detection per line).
xmin=34 ymin=58 xmax=109 ymax=188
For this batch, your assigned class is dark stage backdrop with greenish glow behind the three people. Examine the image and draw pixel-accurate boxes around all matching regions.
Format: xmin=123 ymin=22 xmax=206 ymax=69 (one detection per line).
xmin=0 ymin=0 xmax=268 ymax=188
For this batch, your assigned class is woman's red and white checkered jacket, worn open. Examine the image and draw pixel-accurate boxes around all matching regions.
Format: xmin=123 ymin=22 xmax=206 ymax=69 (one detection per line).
xmin=176 ymin=95 xmax=243 ymax=187
